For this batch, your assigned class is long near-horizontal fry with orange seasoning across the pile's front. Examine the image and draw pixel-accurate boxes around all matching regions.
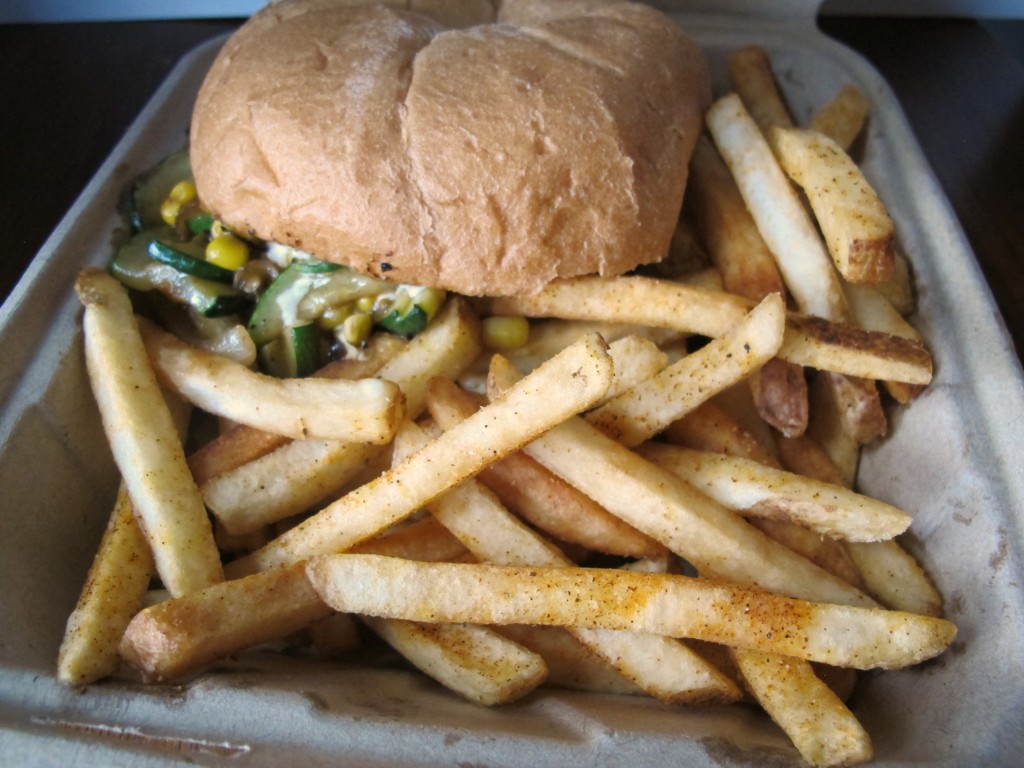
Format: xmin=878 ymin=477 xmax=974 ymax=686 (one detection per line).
xmin=306 ymin=554 xmax=955 ymax=669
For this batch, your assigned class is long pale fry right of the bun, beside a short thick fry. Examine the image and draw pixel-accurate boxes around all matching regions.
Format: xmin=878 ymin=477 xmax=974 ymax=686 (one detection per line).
xmin=706 ymin=94 xmax=850 ymax=323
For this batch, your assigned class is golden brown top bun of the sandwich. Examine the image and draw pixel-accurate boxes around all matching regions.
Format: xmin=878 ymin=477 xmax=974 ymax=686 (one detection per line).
xmin=191 ymin=0 xmax=711 ymax=295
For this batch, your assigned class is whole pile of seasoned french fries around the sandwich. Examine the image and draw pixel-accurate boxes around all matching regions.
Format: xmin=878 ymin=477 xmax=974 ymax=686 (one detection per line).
xmin=58 ymin=48 xmax=955 ymax=766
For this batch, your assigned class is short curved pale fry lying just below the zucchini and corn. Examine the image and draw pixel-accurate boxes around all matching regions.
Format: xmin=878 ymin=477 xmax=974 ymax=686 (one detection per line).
xmin=139 ymin=319 xmax=404 ymax=444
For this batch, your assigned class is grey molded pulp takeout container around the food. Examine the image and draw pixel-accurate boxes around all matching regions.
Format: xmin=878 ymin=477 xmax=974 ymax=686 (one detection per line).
xmin=0 ymin=0 xmax=1024 ymax=768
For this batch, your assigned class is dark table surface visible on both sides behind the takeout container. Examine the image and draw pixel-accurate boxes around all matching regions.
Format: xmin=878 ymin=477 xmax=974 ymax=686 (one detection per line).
xmin=0 ymin=17 xmax=1024 ymax=360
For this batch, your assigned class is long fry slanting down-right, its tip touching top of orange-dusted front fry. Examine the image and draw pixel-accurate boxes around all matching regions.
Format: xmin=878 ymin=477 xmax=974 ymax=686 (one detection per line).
xmin=488 ymin=355 xmax=873 ymax=605
